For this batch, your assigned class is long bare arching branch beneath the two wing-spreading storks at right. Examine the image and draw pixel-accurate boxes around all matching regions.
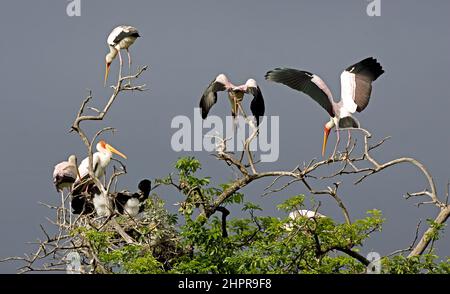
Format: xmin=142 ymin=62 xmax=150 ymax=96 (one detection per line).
xmin=199 ymin=123 xmax=450 ymax=262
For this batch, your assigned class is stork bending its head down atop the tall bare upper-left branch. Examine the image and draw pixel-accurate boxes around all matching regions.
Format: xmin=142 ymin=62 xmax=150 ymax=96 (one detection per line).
xmin=105 ymin=25 xmax=140 ymax=86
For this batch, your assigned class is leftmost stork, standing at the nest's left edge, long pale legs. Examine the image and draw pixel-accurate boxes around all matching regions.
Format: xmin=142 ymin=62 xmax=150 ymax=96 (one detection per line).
xmin=53 ymin=155 xmax=78 ymax=222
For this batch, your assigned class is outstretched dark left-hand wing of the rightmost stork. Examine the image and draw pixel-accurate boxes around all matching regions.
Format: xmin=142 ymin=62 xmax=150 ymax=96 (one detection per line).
xmin=266 ymin=68 xmax=334 ymax=116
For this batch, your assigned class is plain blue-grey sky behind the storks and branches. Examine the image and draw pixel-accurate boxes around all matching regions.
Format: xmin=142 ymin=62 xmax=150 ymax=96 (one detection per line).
xmin=0 ymin=0 xmax=450 ymax=273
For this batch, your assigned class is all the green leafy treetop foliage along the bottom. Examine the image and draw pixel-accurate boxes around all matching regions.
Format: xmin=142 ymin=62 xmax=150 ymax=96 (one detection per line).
xmin=82 ymin=157 xmax=450 ymax=274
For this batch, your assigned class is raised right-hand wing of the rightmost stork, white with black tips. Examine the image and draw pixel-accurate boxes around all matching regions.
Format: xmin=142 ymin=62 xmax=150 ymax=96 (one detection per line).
xmin=341 ymin=57 xmax=384 ymax=113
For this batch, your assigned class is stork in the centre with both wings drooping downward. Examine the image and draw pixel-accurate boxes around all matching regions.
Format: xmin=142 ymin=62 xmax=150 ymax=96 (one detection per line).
xmin=200 ymin=74 xmax=265 ymax=126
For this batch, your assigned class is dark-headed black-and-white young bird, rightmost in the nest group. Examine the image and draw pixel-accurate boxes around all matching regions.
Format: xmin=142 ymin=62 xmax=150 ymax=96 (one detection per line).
xmin=115 ymin=179 xmax=151 ymax=217
